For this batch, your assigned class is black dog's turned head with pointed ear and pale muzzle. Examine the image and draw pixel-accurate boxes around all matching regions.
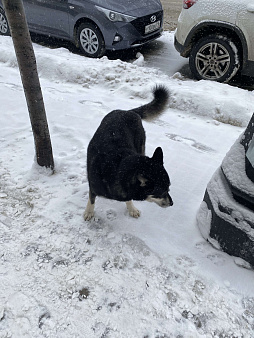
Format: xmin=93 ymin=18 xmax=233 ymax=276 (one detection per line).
xmin=137 ymin=147 xmax=173 ymax=208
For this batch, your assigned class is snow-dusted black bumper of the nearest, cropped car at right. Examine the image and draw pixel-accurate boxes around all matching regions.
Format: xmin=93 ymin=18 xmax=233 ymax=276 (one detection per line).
xmin=197 ymin=168 xmax=254 ymax=267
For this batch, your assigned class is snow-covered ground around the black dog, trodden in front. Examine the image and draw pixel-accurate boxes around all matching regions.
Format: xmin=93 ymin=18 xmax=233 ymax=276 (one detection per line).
xmin=0 ymin=33 xmax=254 ymax=338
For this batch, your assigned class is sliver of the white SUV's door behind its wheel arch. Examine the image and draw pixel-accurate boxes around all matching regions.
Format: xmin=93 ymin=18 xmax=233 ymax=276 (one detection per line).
xmin=237 ymin=0 xmax=254 ymax=61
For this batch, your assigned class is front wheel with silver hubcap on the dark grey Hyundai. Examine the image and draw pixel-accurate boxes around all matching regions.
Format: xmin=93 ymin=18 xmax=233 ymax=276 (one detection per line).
xmin=77 ymin=22 xmax=105 ymax=58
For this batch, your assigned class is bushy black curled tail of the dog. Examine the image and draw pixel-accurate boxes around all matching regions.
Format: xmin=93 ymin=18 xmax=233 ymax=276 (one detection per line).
xmin=132 ymin=85 xmax=169 ymax=121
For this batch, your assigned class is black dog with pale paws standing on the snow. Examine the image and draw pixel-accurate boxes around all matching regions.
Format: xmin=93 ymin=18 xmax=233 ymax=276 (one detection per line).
xmin=84 ymin=85 xmax=173 ymax=221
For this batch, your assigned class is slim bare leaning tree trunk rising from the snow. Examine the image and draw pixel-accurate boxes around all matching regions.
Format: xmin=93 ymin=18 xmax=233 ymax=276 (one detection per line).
xmin=2 ymin=0 xmax=54 ymax=170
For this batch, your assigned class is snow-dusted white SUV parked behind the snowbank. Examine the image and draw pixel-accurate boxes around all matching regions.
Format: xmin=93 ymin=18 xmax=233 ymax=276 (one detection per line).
xmin=174 ymin=0 xmax=254 ymax=82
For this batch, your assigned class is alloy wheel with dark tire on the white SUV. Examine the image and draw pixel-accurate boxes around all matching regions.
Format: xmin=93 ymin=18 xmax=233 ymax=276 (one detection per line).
xmin=189 ymin=35 xmax=240 ymax=82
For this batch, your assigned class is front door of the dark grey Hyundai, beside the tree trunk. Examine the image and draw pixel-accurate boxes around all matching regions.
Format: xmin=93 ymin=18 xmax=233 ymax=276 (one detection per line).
xmin=23 ymin=0 xmax=70 ymax=38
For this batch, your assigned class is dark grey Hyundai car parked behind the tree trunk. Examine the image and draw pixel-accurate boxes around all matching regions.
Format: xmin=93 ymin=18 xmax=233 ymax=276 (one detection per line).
xmin=0 ymin=0 xmax=163 ymax=58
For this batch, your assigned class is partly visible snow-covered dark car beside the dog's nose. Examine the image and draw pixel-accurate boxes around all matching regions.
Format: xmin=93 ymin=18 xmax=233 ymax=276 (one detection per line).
xmin=197 ymin=114 xmax=254 ymax=268
